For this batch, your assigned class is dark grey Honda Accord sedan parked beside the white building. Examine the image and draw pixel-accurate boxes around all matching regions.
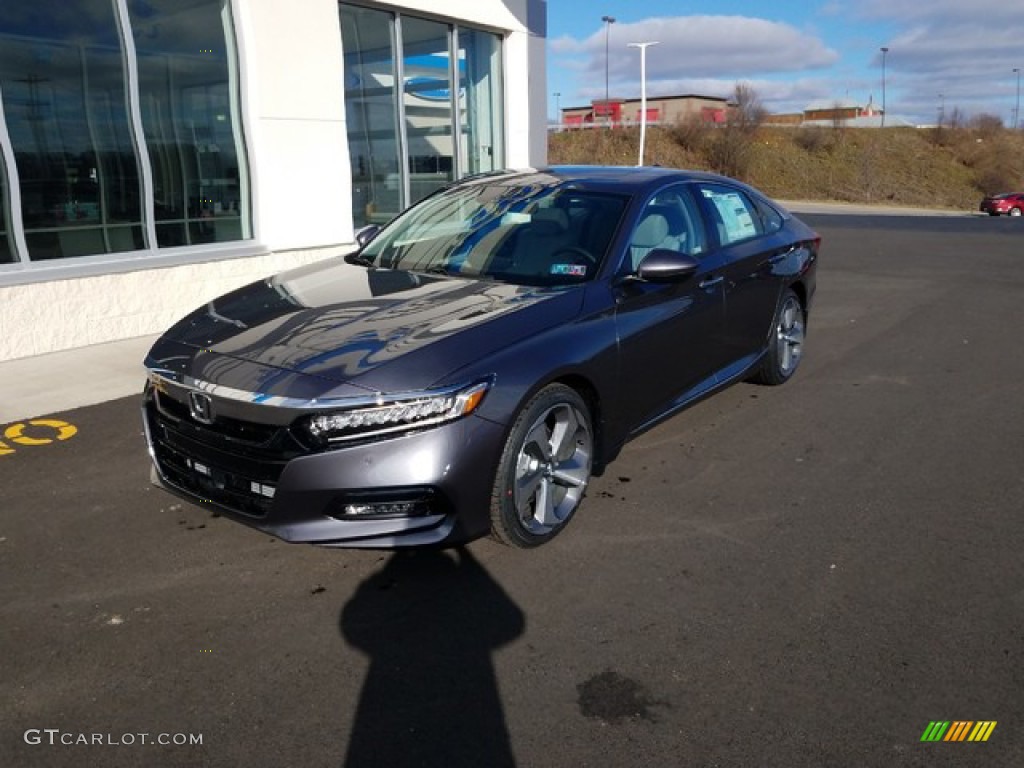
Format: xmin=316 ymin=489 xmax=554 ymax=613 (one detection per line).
xmin=143 ymin=167 xmax=820 ymax=548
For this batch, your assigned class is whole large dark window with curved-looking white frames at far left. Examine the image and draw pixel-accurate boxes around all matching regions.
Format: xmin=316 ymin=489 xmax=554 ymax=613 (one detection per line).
xmin=0 ymin=0 xmax=251 ymax=263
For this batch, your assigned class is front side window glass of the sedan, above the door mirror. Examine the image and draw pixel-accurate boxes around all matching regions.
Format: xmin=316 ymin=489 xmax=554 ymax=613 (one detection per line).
xmin=630 ymin=184 xmax=708 ymax=271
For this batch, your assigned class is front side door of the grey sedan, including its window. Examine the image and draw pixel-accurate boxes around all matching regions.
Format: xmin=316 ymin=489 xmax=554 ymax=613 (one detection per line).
xmin=613 ymin=184 xmax=725 ymax=432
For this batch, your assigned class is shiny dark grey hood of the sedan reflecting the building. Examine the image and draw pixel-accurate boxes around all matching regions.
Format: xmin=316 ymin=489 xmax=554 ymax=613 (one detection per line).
xmin=146 ymin=261 xmax=585 ymax=397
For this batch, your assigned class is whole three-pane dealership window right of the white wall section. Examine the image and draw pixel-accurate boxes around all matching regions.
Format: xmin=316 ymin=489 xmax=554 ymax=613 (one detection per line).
xmin=340 ymin=3 xmax=505 ymax=226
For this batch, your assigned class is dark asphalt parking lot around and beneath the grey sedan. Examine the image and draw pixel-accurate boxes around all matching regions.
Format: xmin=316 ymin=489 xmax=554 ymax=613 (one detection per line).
xmin=0 ymin=214 xmax=1024 ymax=768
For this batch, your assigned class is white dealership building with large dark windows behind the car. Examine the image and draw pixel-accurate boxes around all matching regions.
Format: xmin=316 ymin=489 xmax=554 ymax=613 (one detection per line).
xmin=0 ymin=0 xmax=547 ymax=360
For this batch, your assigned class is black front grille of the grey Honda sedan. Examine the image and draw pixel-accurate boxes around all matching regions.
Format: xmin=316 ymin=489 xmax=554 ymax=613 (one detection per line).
xmin=145 ymin=392 xmax=308 ymax=517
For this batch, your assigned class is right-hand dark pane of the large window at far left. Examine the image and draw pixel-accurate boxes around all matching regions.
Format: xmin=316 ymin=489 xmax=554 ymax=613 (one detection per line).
xmin=128 ymin=0 xmax=251 ymax=248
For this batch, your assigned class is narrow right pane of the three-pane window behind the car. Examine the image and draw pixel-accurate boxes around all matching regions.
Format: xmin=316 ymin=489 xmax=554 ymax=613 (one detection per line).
xmin=459 ymin=28 xmax=505 ymax=174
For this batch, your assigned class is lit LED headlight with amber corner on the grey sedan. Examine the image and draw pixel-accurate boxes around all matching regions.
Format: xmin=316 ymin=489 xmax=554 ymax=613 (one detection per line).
xmin=304 ymin=381 xmax=490 ymax=443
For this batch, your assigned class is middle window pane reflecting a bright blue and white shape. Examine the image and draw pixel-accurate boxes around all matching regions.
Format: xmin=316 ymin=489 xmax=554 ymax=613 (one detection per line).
xmin=401 ymin=16 xmax=455 ymax=204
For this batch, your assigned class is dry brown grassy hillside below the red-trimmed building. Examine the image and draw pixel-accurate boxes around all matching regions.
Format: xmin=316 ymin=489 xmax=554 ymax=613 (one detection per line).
xmin=548 ymin=124 xmax=1024 ymax=210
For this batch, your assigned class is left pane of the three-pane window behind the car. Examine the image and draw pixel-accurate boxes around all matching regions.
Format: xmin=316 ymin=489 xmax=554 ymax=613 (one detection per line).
xmin=341 ymin=5 xmax=404 ymax=227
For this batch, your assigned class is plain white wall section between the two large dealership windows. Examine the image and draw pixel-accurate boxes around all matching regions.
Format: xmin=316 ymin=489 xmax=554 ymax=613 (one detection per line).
xmin=236 ymin=0 xmax=352 ymax=251
